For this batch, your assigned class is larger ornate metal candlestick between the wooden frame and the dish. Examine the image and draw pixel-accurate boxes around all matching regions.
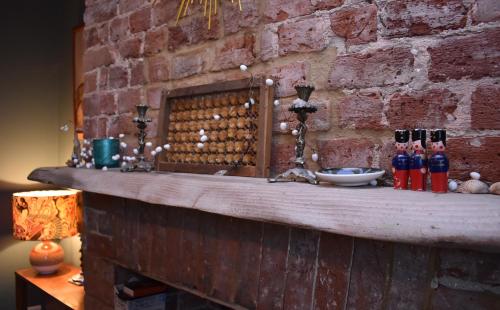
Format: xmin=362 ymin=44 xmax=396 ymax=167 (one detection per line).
xmin=268 ymin=85 xmax=319 ymax=185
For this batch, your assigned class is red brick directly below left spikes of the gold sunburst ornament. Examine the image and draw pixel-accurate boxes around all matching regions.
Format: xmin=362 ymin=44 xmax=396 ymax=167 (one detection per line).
xmin=168 ymin=16 xmax=220 ymax=51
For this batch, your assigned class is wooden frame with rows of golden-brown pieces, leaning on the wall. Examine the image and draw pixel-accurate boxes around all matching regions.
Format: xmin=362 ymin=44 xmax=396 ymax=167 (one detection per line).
xmin=157 ymin=77 xmax=274 ymax=177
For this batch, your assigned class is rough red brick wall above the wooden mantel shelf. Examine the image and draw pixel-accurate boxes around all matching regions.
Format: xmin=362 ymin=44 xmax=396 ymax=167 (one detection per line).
xmin=85 ymin=0 xmax=500 ymax=181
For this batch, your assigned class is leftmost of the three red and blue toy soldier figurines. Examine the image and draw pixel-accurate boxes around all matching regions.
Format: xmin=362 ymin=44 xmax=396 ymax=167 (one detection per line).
xmin=392 ymin=130 xmax=410 ymax=189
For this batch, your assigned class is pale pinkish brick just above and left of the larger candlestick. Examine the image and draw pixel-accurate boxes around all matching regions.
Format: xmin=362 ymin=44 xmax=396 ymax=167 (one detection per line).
xmin=272 ymin=61 xmax=310 ymax=97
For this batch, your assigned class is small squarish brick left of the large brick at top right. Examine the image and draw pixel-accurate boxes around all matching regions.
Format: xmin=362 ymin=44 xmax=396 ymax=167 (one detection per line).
xmin=330 ymin=4 xmax=377 ymax=45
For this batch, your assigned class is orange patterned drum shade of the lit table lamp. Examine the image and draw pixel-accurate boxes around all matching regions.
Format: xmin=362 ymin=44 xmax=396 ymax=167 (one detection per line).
xmin=12 ymin=190 xmax=80 ymax=241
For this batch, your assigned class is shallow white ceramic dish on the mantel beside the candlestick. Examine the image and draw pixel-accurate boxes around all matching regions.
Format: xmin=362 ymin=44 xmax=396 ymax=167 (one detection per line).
xmin=316 ymin=168 xmax=385 ymax=186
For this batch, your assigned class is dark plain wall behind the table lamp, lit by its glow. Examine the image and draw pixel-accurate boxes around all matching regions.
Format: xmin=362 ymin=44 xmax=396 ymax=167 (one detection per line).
xmin=0 ymin=0 xmax=84 ymax=309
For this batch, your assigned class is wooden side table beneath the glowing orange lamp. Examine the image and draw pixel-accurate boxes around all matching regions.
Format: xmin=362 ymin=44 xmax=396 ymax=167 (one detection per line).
xmin=16 ymin=264 xmax=84 ymax=310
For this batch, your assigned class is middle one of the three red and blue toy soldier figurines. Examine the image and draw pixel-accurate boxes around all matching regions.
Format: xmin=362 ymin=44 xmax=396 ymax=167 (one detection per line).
xmin=410 ymin=129 xmax=427 ymax=191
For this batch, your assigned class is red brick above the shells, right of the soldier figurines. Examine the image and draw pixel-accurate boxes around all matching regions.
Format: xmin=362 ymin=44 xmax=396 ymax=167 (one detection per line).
xmin=446 ymin=137 xmax=500 ymax=182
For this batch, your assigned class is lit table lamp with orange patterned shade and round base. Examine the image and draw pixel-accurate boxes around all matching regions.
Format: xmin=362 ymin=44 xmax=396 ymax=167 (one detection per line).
xmin=12 ymin=190 xmax=80 ymax=274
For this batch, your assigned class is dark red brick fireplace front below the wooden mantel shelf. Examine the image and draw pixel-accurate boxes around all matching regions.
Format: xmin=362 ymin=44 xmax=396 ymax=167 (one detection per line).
xmin=83 ymin=193 xmax=500 ymax=310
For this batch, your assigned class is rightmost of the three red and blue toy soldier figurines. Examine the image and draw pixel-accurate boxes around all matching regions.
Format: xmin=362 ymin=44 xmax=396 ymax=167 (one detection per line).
xmin=429 ymin=129 xmax=449 ymax=193
